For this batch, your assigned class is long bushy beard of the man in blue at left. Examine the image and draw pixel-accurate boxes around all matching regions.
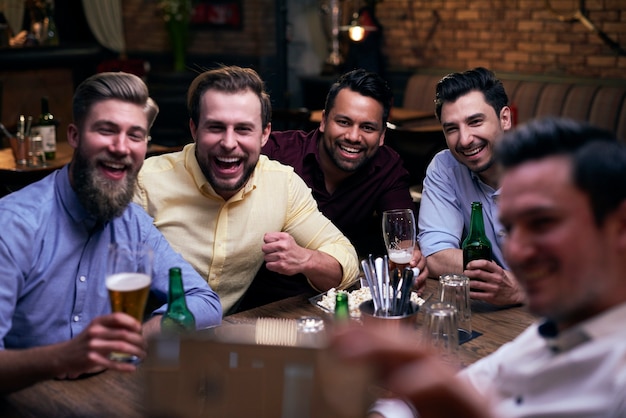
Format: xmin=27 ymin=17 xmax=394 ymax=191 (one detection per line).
xmin=72 ymin=146 xmax=138 ymax=222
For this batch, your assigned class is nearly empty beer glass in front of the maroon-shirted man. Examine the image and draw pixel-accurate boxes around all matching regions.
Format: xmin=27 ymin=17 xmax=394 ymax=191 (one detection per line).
xmin=382 ymin=209 xmax=417 ymax=270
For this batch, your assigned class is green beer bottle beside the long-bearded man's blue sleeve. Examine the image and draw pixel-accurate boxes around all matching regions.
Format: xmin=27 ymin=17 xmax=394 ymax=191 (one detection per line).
xmin=161 ymin=267 xmax=196 ymax=334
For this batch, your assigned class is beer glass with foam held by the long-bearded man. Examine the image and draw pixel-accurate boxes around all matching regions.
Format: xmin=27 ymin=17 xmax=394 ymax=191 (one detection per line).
xmin=105 ymin=242 xmax=153 ymax=364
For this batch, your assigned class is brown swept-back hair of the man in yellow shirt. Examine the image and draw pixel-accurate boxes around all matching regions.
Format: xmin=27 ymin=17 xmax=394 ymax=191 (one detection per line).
xmin=187 ymin=65 xmax=272 ymax=128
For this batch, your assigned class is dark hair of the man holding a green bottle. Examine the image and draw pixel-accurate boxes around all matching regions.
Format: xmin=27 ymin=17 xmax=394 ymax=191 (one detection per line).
xmin=435 ymin=67 xmax=509 ymax=120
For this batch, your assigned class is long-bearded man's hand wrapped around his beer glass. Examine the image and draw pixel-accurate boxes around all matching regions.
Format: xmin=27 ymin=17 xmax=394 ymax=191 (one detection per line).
xmin=56 ymin=312 xmax=146 ymax=379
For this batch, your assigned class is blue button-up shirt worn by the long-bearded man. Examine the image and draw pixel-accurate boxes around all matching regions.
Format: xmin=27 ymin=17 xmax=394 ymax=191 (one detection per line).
xmin=0 ymin=167 xmax=222 ymax=348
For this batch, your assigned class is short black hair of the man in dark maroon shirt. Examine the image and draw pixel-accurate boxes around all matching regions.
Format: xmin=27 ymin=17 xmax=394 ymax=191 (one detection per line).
xmin=324 ymin=68 xmax=393 ymax=124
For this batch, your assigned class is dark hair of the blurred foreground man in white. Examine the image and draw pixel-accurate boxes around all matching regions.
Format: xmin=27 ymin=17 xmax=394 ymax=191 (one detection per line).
xmin=496 ymin=117 xmax=626 ymax=225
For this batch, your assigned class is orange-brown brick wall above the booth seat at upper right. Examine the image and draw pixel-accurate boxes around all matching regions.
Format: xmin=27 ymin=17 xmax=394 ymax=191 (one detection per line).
xmin=377 ymin=0 xmax=626 ymax=79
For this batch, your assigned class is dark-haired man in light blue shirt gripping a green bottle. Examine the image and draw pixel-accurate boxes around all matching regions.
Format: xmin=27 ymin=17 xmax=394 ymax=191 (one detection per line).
xmin=418 ymin=68 xmax=524 ymax=305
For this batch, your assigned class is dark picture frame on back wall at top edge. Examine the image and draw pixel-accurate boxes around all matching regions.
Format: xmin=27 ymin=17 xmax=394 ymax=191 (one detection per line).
xmin=191 ymin=0 xmax=243 ymax=30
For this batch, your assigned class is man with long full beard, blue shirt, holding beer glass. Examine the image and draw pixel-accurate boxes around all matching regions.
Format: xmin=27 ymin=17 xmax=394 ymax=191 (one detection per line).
xmin=0 ymin=73 xmax=222 ymax=392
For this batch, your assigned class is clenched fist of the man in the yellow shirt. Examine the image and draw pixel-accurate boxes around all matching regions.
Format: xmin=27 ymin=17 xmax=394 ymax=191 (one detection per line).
xmin=261 ymin=232 xmax=314 ymax=276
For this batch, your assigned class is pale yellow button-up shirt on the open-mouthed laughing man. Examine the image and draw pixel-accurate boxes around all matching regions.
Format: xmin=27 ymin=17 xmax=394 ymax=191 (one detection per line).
xmin=134 ymin=144 xmax=358 ymax=313
